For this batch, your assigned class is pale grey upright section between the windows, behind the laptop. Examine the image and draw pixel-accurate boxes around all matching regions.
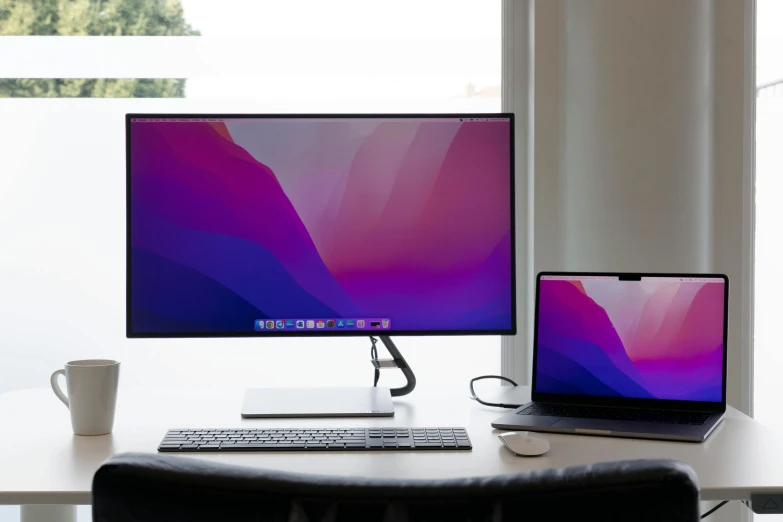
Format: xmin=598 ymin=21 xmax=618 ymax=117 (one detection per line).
xmin=503 ymin=0 xmax=755 ymax=412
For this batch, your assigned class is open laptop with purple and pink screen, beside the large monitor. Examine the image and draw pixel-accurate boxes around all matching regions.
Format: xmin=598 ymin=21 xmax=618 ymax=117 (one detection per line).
xmin=492 ymin=272 xmax=729 ymax=442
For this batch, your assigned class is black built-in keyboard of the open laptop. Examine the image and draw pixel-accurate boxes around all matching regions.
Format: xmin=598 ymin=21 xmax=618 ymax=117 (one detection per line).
xmin=517 ymin=403 xmax=712 ymax=426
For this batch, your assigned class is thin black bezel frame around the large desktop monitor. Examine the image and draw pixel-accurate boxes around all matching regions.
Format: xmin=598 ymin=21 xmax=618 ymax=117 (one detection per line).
xmin=125 ymin=112 xmax=518 ymax=339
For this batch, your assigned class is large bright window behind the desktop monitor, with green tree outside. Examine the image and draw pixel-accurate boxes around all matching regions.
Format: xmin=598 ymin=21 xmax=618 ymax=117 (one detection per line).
xmin=0 ymin=0 xmax=501 ymax=398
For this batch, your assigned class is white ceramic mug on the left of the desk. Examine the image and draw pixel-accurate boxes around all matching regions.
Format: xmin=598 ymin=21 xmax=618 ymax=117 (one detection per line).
xmin=51 ymin=359 xmax=120 ymax=435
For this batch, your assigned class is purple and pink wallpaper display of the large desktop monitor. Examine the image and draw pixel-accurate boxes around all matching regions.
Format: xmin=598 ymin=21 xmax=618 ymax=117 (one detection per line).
xmin=129 ymin=117 xmax=513 ymax=335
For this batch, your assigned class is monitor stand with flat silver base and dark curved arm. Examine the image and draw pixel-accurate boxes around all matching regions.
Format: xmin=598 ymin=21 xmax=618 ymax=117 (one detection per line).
xmin=242 ymin=335 xmax=416 ymax=418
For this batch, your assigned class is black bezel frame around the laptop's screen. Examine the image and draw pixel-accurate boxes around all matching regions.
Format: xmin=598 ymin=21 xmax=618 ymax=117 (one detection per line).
xmin=530 ymin=272 xmax=729 ymax=412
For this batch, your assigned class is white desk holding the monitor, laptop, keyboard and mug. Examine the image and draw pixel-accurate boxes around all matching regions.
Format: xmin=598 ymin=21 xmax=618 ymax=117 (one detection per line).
xmin=0 ymin=388 xmax=783 ymax=520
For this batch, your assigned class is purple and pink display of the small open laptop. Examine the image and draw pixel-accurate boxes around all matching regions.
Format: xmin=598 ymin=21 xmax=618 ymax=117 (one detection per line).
xmin=536 ymin=276 xmax=726 ymax=402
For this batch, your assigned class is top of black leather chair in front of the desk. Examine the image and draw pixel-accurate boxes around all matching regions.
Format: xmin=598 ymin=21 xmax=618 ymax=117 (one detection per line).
xmin=93 ymin=453 xmax=699 ymax=522
